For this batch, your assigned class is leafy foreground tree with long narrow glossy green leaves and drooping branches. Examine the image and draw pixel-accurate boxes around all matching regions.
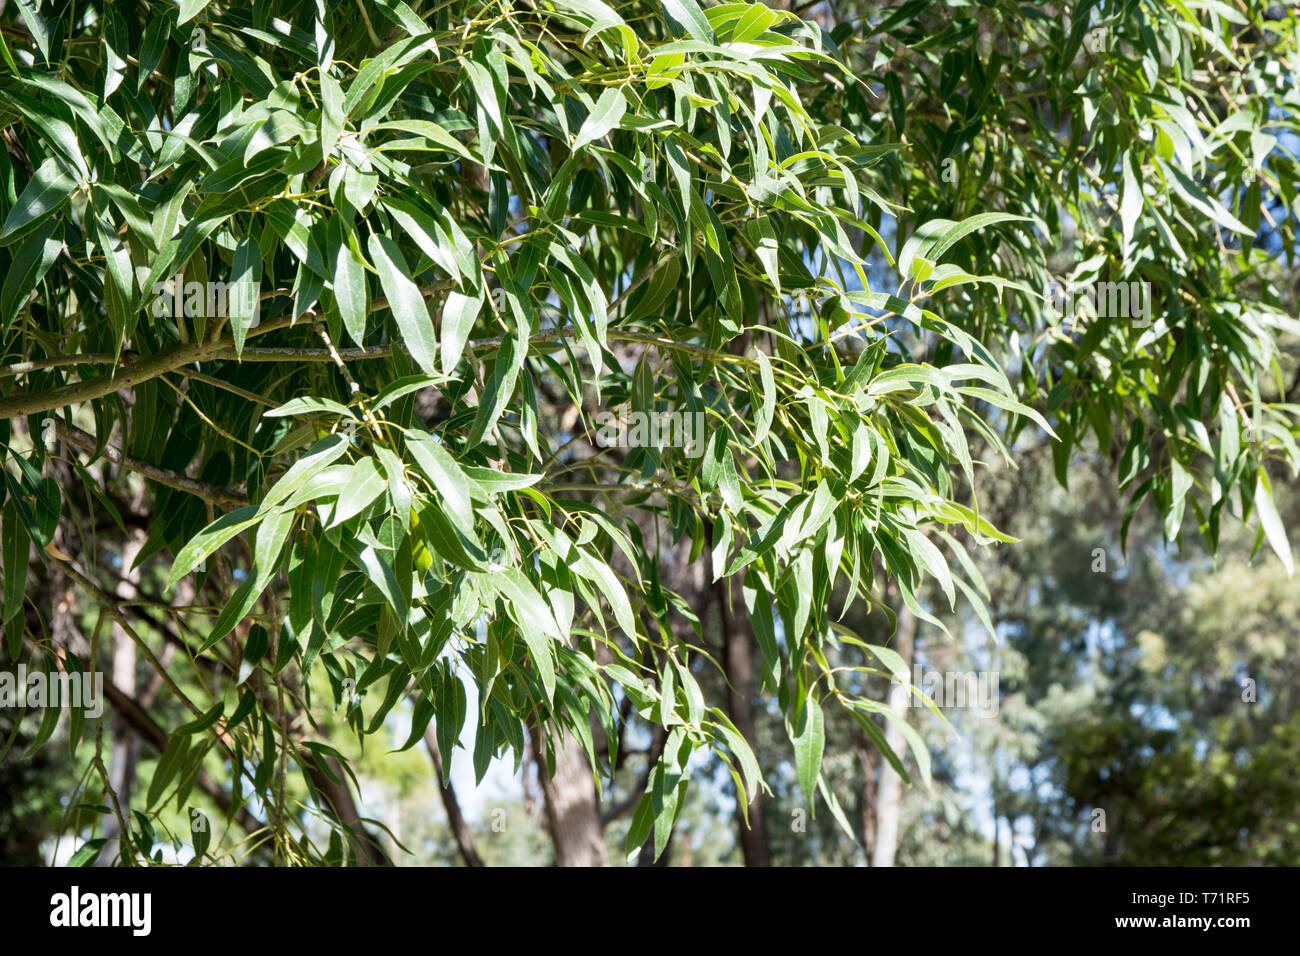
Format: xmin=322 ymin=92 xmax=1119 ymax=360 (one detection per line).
xmin=0 ymin=0 xmax=1300 ymax=864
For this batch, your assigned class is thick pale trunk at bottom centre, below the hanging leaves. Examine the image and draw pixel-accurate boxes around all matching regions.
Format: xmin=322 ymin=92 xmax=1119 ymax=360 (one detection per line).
xmin=533 ymin=727 xmax=608 ymax=866
